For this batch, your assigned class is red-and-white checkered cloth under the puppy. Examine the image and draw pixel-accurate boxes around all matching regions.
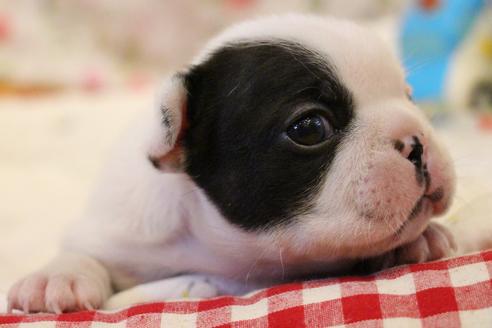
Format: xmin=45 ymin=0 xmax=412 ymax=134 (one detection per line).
xmin=0 ymin=250 xmax=492 ymax=328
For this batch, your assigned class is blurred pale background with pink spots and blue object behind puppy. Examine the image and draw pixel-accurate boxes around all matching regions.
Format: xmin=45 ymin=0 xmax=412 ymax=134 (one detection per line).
xmin=0 ymin=0 xmax=492 ymax=304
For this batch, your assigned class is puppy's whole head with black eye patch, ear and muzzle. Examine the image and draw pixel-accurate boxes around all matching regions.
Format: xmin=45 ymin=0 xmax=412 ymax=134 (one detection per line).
xmin=150 ymin=16 xmax=454 ymax=266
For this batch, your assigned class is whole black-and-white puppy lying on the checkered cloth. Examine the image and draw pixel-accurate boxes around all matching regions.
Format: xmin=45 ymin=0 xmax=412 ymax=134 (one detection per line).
xmin=9 ymin=15 xmax=455 ymax=313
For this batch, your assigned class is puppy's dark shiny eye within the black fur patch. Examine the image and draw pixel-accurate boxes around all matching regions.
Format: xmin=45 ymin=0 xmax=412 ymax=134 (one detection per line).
xmin=287 ymin=114 xmax=333 ymax=146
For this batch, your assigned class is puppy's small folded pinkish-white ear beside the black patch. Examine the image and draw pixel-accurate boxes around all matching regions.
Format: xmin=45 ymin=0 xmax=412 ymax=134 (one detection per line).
xmin=148 ymin=74 xmax=187 ymax=172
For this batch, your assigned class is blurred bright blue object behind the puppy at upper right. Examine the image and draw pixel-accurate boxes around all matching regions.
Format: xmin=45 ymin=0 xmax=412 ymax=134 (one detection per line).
xmin=399 ymin=0 xmax=486 ymax=103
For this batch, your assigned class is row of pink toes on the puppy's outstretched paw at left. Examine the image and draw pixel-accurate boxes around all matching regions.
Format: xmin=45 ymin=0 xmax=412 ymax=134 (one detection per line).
xmin=8 ymin=272 xmax=105 ymax=313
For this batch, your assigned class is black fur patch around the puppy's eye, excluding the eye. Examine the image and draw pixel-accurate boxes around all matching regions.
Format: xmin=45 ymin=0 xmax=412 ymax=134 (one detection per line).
xmin=184 ymin=40 xmax=354 ymax=230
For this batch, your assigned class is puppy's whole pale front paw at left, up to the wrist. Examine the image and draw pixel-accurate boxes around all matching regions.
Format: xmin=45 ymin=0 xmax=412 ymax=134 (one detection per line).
xmin=8 ymin=253 xmax=111 ymax=313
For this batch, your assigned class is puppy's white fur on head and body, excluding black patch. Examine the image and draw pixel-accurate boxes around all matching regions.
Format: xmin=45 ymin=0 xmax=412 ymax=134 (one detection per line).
xmin=9 ymin=15 xmax=462 ymax=312
